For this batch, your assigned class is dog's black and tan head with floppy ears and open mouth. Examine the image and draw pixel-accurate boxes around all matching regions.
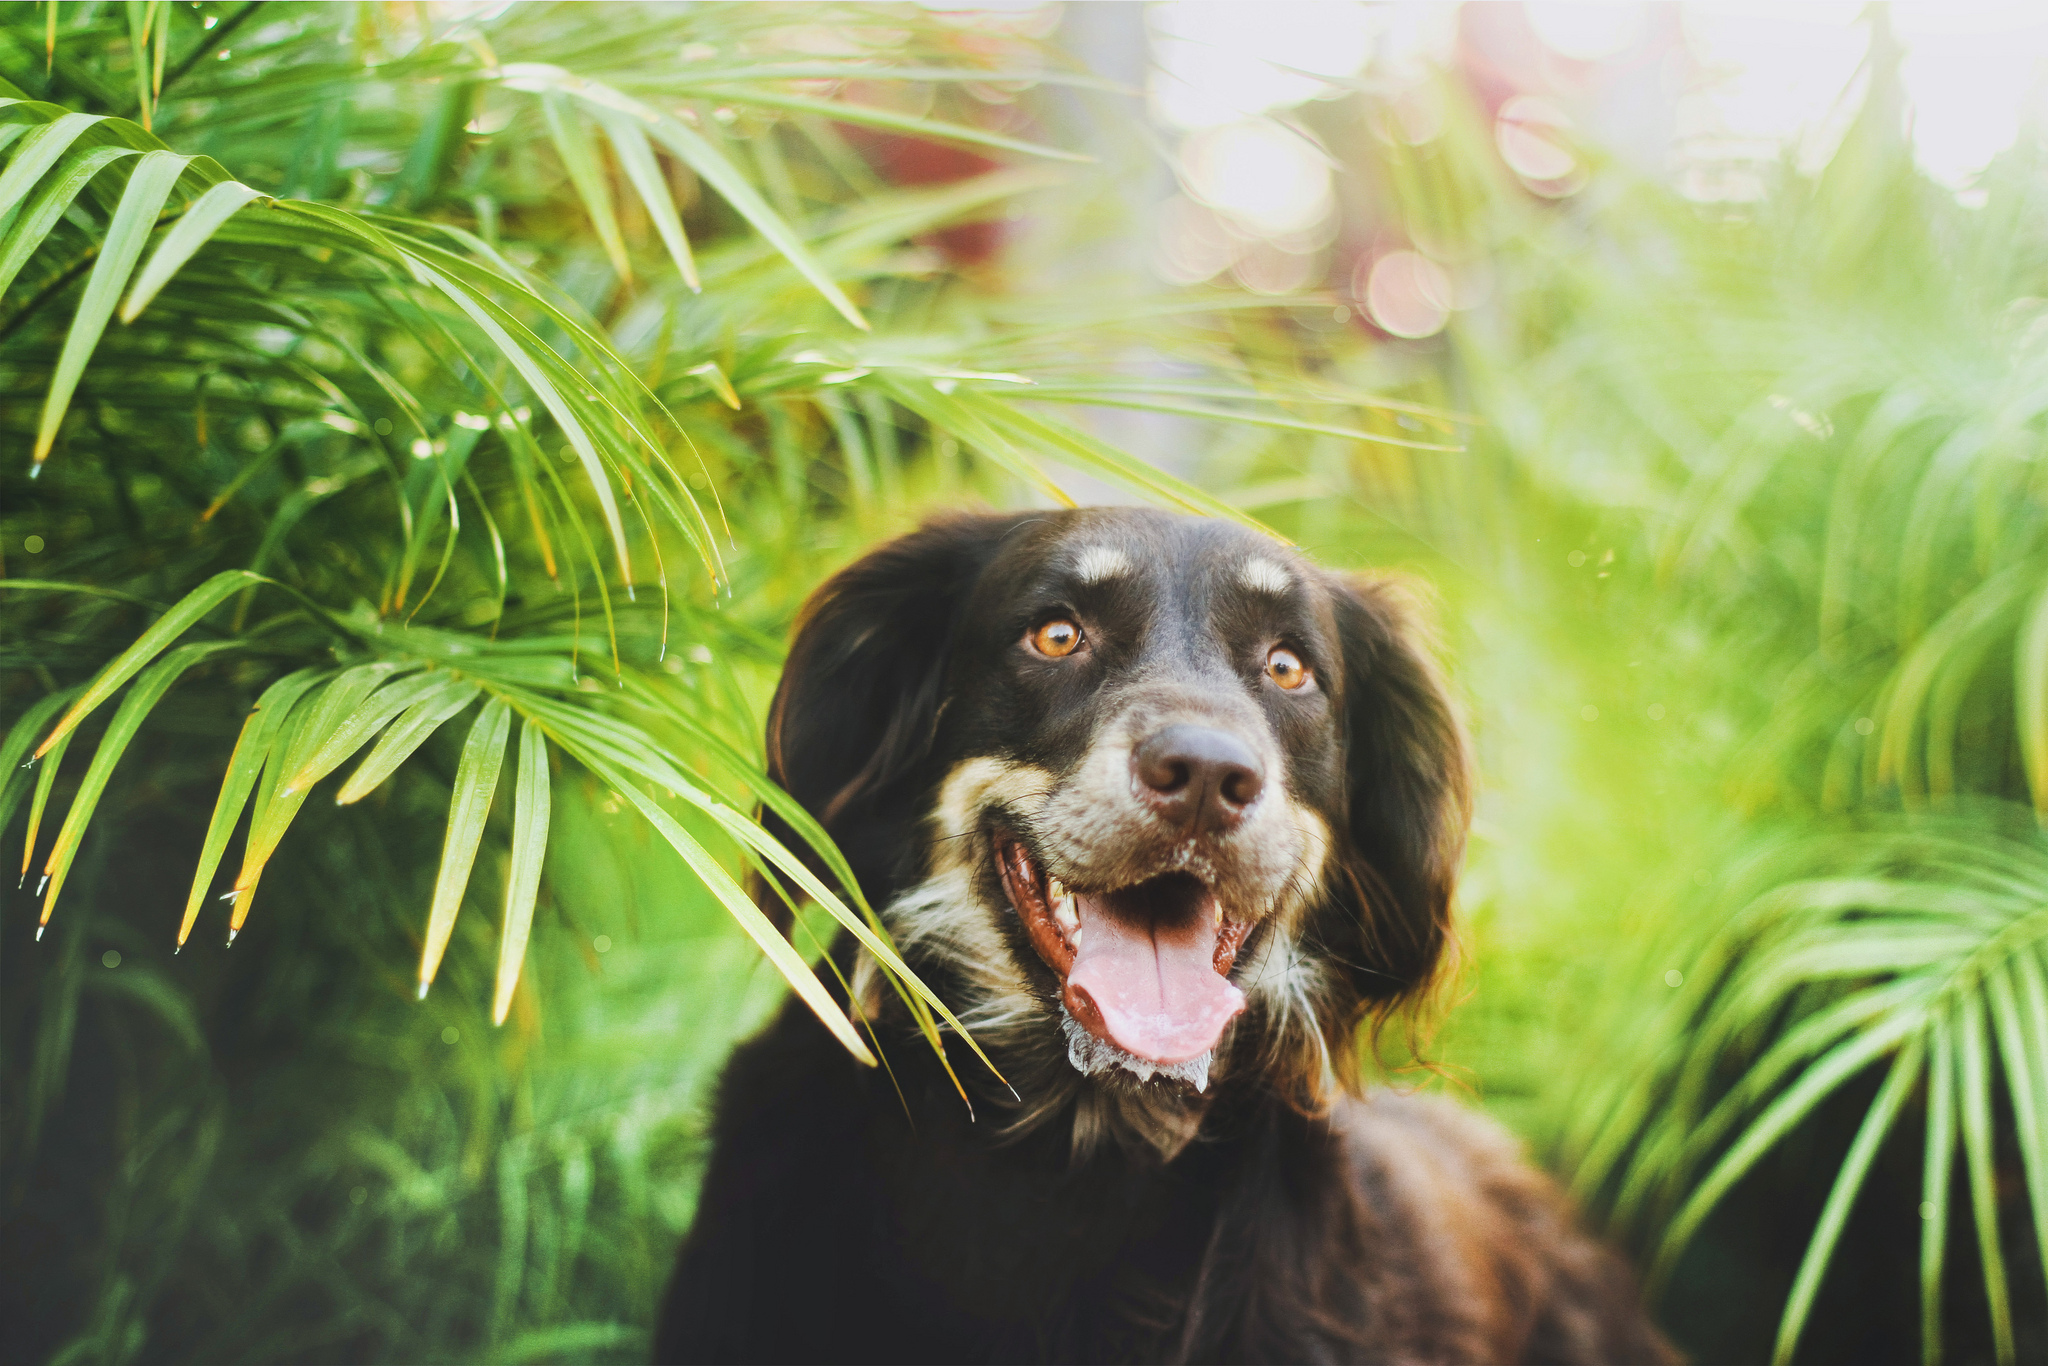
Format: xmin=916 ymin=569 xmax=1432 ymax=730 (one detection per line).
xmin=768 ymin=508 xmax=1468 ymax=1147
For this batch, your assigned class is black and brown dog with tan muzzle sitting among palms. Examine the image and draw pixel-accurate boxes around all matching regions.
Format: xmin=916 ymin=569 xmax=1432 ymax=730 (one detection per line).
xmin=655 ymin=510 xmax=1673 ymax=1362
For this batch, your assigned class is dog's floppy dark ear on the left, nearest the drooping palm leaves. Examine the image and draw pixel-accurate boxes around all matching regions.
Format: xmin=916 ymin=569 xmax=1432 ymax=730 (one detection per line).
xmin=764 ymin=514 xmax=1032 ymax=905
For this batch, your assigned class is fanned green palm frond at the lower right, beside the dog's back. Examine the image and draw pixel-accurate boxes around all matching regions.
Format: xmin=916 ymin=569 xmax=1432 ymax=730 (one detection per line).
xmin=1581 ymin=819 xmax=2048 ymax=1360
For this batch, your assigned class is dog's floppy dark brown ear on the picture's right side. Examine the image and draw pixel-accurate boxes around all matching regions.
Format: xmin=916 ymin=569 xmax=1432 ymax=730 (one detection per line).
xmin=1331 ymin=580 xmax=1473 ymax=1001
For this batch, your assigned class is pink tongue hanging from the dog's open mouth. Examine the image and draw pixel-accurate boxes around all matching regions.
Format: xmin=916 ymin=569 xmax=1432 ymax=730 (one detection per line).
xmin=1067 ymin=895 xmax=1245 ymax=1063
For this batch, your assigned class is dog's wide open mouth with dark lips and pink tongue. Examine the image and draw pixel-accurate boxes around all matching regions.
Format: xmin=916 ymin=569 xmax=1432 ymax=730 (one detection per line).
xmin=995 ymin=831 xmax=1251 ymax=1077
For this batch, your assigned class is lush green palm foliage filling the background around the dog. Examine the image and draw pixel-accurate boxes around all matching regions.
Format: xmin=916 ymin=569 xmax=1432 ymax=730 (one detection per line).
xmin=0 ymin=4 xmax=2048 ymax=1362
